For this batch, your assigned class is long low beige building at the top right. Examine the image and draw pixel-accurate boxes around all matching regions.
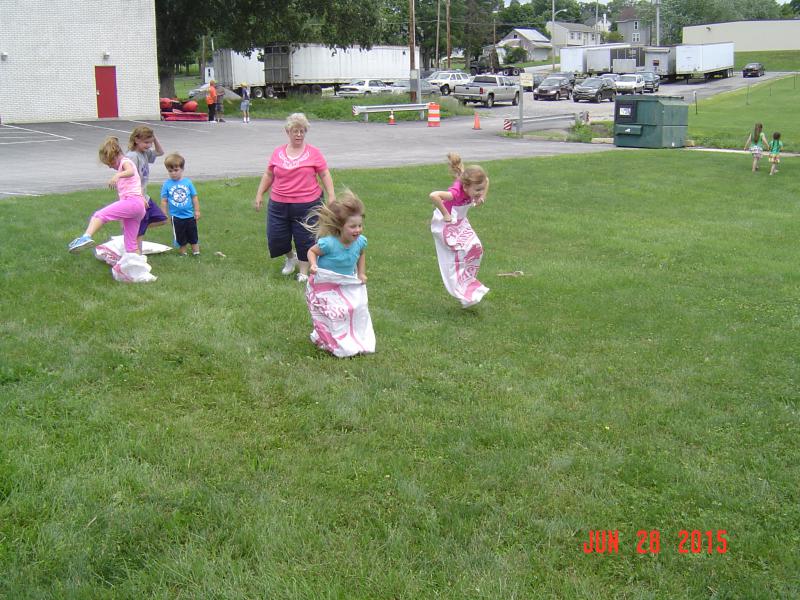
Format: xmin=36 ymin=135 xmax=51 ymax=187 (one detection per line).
xmin=683 ymin=20 xmax=800 ymax=52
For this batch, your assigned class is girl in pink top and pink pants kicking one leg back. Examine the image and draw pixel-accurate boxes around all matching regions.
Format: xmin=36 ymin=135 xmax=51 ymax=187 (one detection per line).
xmin=68 ymin=137 xmax=147 ymax=254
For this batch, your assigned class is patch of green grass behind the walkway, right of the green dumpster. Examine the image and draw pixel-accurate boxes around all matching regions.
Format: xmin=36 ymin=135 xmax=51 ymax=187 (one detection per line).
xmin=689 ymin=75 xmax=800 ymax=152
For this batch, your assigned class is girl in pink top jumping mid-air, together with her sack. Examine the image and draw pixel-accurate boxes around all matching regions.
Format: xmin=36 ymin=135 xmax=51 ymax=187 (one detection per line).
xmin=430 ymin=152 xmax=489 ymax=308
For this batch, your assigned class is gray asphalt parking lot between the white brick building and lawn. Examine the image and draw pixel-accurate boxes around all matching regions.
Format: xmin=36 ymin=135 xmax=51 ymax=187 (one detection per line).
xmin=0 ymin=117 xmax=612 ymax=198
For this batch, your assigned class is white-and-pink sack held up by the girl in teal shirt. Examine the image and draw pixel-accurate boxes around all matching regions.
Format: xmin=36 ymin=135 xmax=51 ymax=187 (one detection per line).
xmin=306 ymin=269 xmax=375 ymax=358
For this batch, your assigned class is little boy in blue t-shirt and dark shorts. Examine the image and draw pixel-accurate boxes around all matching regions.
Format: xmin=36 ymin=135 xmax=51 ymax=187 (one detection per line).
xmin=161 ymin=152 xmax=200 ymax=256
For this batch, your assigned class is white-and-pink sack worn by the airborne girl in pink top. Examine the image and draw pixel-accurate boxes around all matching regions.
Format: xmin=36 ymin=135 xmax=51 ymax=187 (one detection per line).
xmin=431 ymin=205 xmax=489 ymax=308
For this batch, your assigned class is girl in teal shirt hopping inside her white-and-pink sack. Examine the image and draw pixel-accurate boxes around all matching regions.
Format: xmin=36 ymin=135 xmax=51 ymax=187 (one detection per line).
xmin=305 ymin=190 xmax=375 ymax=358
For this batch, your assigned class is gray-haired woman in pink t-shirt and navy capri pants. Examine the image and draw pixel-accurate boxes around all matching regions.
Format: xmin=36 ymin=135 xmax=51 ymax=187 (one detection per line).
xmin=255 ymin=113 xmax=333 ymax=281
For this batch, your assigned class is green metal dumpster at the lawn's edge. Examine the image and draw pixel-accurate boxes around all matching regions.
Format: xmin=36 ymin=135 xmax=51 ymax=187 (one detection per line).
xmin=614 ymin=95 xmax=689 ymax=148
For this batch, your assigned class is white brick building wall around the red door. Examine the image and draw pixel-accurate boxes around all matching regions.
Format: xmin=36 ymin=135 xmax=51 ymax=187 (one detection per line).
xmin=0 ymin=0 xmax=159 ymax=123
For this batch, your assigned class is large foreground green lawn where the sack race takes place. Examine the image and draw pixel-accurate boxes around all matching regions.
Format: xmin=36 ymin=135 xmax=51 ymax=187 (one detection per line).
xmin=0 ymin=149 xmax=800 ymax=599
